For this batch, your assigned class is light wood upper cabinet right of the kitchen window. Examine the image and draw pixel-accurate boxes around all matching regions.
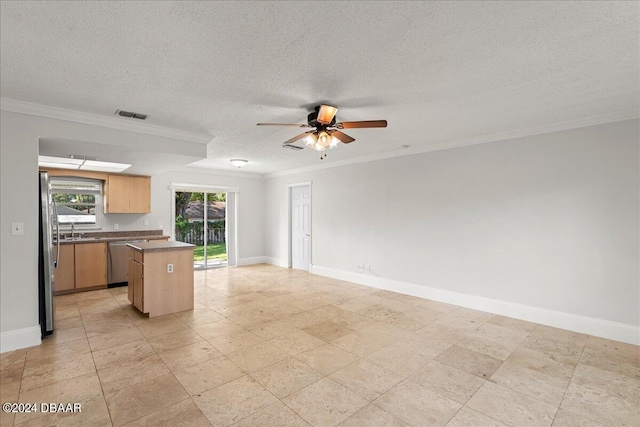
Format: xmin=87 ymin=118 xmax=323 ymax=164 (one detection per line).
xmin=104 ymin=175 xmax=151 ymax=213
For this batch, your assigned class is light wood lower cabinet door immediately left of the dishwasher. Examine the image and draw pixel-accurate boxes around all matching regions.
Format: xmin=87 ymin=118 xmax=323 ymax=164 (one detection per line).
xmin=75 ymin=243 xmax=107 ymax=289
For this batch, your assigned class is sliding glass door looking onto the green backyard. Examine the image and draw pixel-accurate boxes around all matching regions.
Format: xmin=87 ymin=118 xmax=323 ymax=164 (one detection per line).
xmin=175 ymin=191 xmax=227 ymax=269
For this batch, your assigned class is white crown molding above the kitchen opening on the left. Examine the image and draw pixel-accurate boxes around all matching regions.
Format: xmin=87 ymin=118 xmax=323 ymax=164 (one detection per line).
xmin=0 ymin=98 xmax=214 ymax=144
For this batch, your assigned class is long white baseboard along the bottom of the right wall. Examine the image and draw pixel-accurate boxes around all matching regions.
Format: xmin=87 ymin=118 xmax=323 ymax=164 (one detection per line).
xmin=311 ymin=265 xmax=640 ymax=345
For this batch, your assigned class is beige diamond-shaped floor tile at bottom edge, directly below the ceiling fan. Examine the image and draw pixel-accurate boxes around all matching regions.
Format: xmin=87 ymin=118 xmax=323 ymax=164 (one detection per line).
xmin=282 ymin=378 xmax=368 ymax=426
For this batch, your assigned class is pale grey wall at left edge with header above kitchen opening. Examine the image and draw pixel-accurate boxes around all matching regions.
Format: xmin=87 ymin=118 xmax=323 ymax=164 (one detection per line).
xmin=0 ymin=110 xmax=206 ymax=351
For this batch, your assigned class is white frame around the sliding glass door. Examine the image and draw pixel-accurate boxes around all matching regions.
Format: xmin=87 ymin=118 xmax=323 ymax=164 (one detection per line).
xmin=169 ymin=182 xmax=240 ymax=267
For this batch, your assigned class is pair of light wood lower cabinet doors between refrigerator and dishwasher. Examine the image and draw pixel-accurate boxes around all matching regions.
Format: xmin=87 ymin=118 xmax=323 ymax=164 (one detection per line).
xmin=54 ymin=243 xmax=107 ymax=294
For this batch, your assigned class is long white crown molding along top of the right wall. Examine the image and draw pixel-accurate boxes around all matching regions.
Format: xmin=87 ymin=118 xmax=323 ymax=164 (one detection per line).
xmin=264 ymin=109 xmax=640 ymax=179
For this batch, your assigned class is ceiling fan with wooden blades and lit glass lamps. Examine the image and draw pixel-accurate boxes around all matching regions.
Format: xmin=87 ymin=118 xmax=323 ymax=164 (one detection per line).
xmin=258 ymin=104 xmax=387 ymax=159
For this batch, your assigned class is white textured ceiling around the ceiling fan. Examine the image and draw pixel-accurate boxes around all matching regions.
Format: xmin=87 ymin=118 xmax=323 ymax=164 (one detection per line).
xmin=0 ymin=1 xmax=640 ymax=173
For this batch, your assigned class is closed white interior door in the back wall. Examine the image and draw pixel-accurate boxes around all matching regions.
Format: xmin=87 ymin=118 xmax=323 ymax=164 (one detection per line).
xmin=291 ymin=185 xmax=311 ymax=271
